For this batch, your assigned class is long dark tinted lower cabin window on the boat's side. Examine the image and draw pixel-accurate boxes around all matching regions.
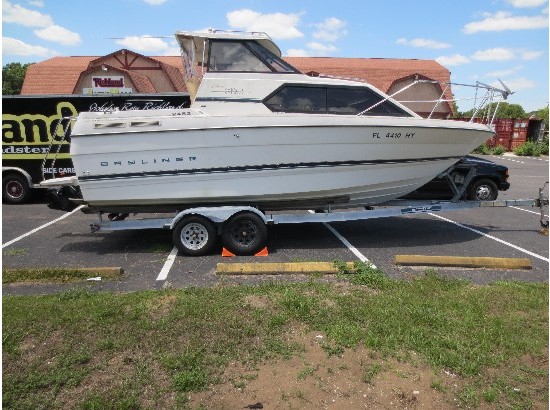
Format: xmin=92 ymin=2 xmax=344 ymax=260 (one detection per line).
xmin=264 ymin=85 xmax=411 ymax=117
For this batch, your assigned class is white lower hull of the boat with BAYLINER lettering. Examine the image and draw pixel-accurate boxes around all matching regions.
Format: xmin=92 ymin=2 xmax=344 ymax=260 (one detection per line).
xmin=67 ymin=111 xmax=492 ymax=215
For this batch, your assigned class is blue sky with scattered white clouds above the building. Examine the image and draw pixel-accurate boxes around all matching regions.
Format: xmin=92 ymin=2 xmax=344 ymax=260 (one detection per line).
xmin=2 ymin=0 xmax=549 ymax=112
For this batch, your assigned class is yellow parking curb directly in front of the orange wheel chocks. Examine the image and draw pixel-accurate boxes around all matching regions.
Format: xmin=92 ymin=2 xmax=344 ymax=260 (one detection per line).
xmin=216 ymin=262 xmax=354 ymax=275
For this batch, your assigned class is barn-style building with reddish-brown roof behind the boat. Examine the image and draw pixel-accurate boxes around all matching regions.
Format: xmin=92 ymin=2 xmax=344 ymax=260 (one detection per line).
xmin=21 ymin=49 xmax=453 ymax=118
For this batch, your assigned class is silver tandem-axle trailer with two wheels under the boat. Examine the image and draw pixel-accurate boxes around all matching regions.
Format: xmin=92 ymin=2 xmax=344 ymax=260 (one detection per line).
xmin=90 ymin=189 xmax=548 ymax=256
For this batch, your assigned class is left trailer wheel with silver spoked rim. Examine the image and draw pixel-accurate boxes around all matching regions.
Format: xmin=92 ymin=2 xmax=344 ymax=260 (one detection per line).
xmin=172 ymin=215 xmax=218 ymax=256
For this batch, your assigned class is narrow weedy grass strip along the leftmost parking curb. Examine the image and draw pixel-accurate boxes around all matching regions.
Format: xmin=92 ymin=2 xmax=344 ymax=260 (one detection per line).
xmin=2 ymin=267 xmax=123 ymax=284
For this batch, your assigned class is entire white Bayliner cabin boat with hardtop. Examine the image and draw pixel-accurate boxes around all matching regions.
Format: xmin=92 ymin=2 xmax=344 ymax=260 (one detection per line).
xmin=46 ymin=31 xmax=500 ymax=212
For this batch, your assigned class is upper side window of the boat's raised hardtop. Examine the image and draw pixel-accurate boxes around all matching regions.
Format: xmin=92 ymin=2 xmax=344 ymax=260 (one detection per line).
xmin=208 ymin=40 xmax=299 ymax=73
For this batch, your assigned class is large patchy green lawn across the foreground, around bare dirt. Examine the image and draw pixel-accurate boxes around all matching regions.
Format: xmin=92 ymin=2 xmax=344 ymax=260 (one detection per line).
xmin=2 ymin=266 xmax=548 ymax=409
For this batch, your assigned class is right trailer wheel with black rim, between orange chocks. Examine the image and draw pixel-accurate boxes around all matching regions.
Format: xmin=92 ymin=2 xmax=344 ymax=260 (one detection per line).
xmin=222 ymin=212 xmax=267 ymax=255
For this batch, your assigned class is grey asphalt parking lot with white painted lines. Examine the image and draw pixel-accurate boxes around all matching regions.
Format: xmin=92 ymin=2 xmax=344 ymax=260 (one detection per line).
xmin=2 ymin=155 xmax=549 ymax=295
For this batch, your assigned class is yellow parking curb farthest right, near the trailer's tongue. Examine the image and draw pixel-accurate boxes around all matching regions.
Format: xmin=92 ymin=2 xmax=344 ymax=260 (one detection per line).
xmin=394 ymin=255 xmax=533 ymax=269
